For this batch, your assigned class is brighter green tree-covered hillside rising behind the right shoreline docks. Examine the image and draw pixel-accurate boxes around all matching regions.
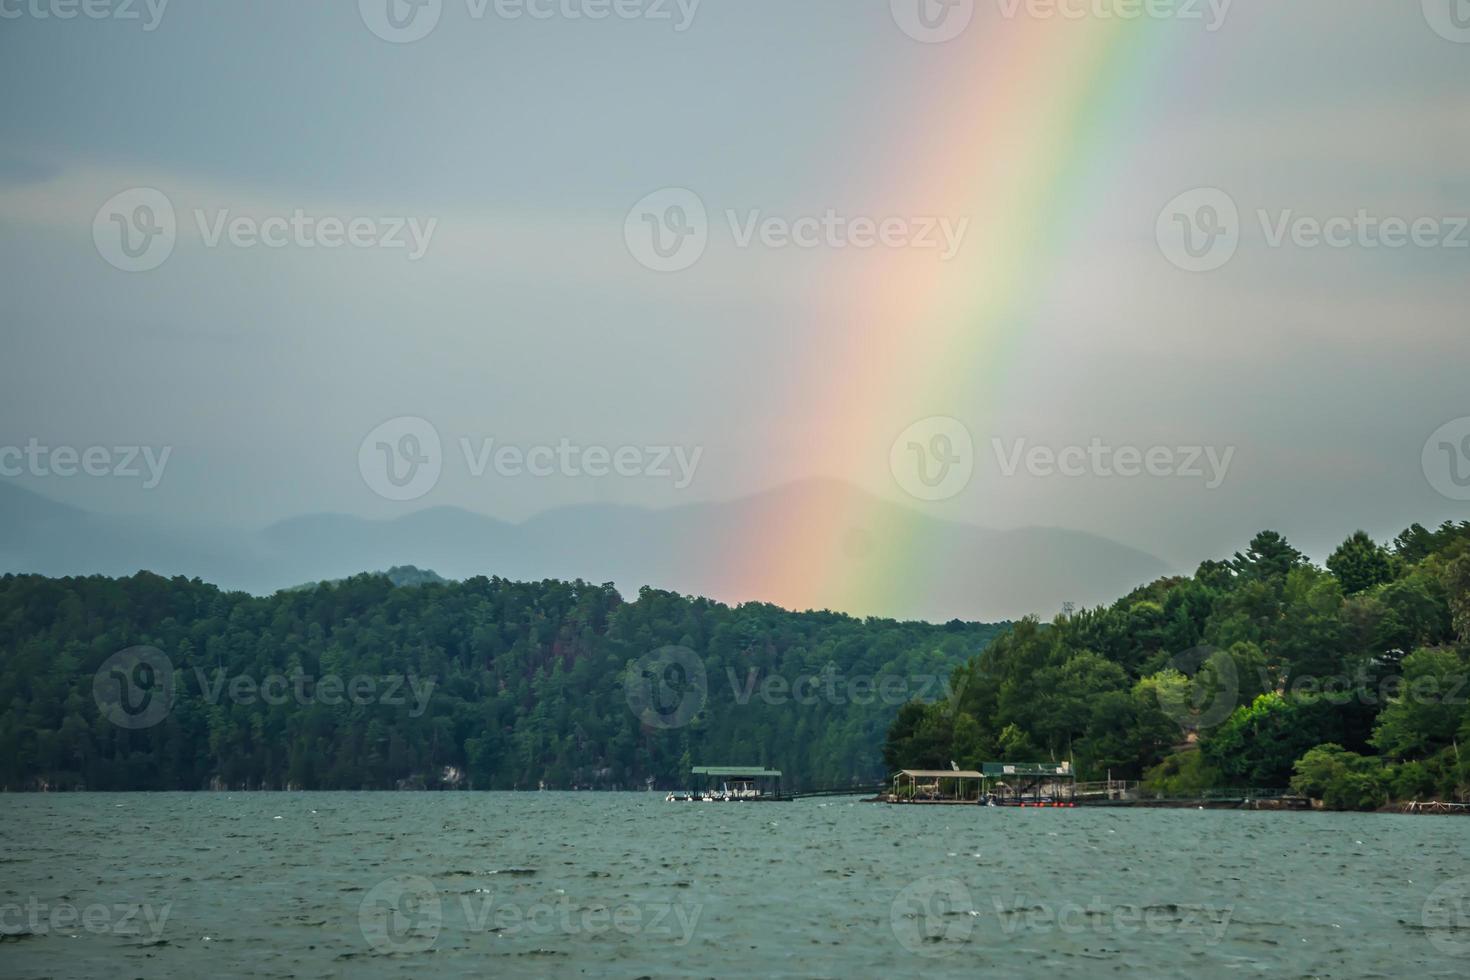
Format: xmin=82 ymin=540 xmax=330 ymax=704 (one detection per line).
xmin=885 ymin=523 xmax=1470 ymax=808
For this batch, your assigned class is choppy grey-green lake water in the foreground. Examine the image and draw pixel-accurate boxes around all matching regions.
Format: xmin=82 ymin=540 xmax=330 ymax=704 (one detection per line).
xmin=0 ymin=793 xmax=1470 ymax=977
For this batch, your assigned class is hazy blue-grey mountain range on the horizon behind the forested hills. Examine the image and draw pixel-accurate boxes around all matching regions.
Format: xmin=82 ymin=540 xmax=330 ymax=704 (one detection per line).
xmin=0 ymin=480 xmax=1170 ymax=620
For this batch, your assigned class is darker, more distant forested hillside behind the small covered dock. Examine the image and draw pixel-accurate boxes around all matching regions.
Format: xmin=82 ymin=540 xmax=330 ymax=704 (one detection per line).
xmin=0 ymin=570 xmax=998 ymax=789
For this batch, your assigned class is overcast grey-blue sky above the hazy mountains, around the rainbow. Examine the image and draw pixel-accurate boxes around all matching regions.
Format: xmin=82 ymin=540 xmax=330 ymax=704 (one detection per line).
xmin=0 ymin=0 xmax=1470 ymax=567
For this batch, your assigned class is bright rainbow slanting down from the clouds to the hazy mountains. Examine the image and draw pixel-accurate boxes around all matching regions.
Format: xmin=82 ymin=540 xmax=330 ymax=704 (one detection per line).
xmin=720 ymin=15 xmax=1181 ymax=614
